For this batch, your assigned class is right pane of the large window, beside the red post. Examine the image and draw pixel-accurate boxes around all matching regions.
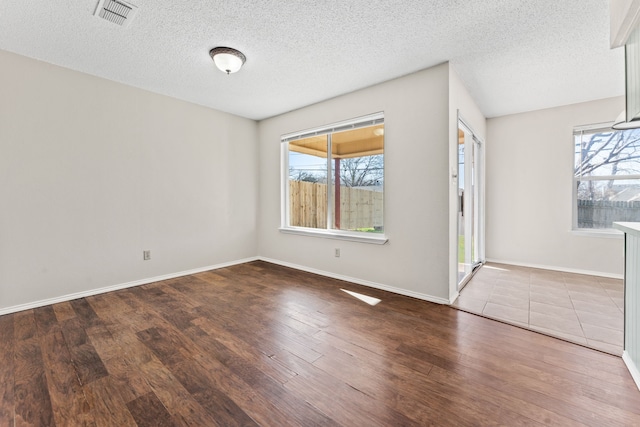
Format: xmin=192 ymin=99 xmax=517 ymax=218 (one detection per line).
xmin=331 ymin=125 xmax=384 ymax=233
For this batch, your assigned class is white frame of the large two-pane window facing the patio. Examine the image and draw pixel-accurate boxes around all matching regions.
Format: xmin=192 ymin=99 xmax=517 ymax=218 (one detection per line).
xmin=279 ymin=112 xmax=389 ymax=245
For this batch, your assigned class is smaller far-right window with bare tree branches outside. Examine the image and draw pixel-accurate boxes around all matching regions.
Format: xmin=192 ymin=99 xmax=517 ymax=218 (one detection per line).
xmin=573 ymin=125 xmax=640 ymax=230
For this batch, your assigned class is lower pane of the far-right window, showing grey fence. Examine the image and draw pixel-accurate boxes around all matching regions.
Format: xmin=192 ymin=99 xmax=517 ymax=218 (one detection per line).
xmin=577 ymin=179 xmax=640 ymax=229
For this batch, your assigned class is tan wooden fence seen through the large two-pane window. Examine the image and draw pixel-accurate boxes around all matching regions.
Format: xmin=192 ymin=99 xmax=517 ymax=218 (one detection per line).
xmin=289 ymin=180 xmax=383 ymax=230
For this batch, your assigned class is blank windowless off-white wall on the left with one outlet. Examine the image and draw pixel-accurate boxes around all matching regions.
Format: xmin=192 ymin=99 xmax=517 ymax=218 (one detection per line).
xmin=0 ymin=51 xmax=258 ymax=312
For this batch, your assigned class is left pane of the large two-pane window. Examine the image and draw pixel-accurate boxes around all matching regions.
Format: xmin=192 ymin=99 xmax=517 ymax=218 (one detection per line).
xmin=289 ymin=135 xmax=327 ymax=229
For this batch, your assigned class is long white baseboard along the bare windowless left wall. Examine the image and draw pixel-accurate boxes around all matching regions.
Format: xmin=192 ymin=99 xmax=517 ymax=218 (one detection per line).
xmin=0 ymin=257 xmax=259 ymax=316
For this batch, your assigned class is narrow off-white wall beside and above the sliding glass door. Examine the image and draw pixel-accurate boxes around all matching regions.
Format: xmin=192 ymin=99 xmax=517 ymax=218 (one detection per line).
xmin=449 ymin=67 xmax=487 ymax=301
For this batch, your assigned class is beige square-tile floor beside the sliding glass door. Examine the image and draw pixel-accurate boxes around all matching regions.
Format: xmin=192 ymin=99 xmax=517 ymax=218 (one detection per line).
xmin=453 ymin=263 xmax=624 ymax=356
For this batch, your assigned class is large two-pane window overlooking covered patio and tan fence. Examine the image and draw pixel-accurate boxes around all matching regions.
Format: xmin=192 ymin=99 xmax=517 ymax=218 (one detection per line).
xmin=282 ymin=113 xmax=386 ymax=243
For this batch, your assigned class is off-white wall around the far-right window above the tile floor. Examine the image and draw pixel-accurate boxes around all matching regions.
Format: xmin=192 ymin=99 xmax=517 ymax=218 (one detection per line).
xmin=486 ymin=97 xmax=624 ymax=275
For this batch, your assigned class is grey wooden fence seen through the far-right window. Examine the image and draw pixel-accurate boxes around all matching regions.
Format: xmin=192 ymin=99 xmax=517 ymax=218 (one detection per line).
xmin=578 ymin=200 xmax=640 ymax=228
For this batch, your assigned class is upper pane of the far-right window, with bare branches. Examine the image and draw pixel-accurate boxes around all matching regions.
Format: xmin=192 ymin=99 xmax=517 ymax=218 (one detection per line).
xmin=574 ymin=129 xmax=640 ymax=177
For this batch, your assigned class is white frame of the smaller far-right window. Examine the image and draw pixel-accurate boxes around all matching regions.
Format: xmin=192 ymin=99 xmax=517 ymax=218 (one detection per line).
xmin=571 ymin=122 xmax=640 ymax=238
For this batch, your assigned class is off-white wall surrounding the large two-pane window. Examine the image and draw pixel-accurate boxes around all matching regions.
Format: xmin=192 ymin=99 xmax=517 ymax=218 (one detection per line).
xmin=259 ymin=64 xmax=450 ymax=302
